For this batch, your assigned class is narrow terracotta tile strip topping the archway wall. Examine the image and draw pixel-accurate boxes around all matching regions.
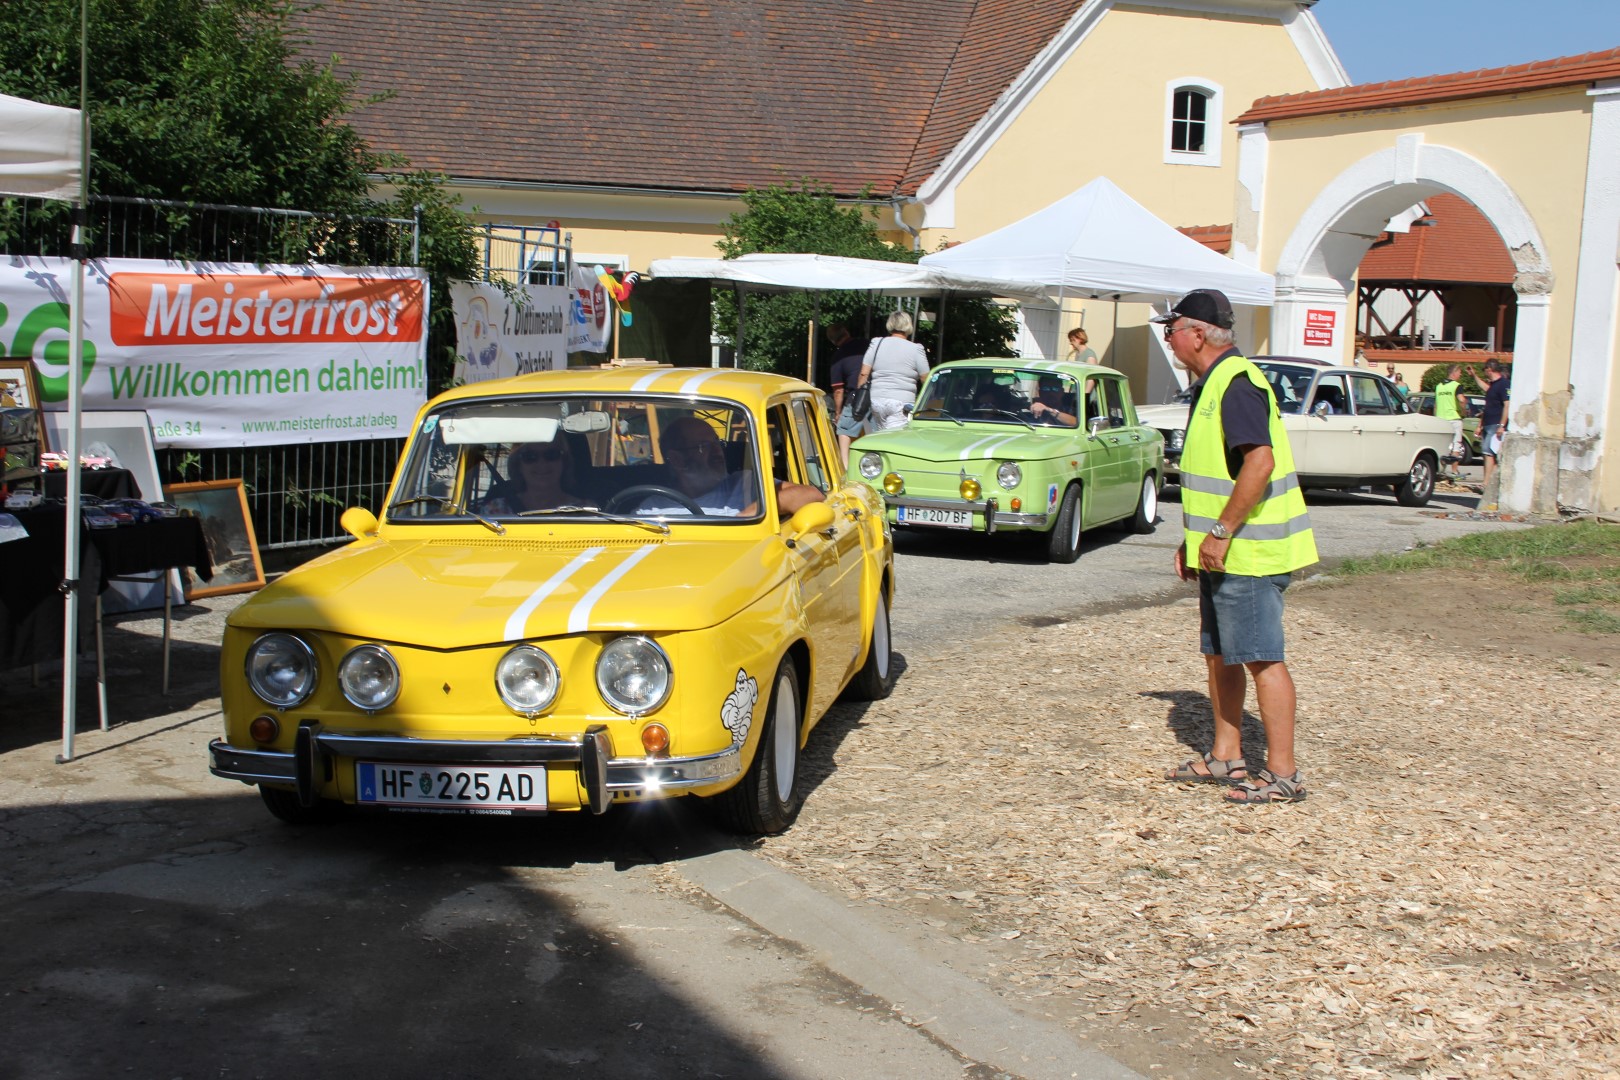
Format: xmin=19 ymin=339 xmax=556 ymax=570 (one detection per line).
xmin=1233 ymin=49 xmax=1620 ymax=123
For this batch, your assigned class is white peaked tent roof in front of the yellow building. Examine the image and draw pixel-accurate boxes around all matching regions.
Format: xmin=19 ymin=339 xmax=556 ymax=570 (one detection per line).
xmin=920 ymin=176 xmax=1273 ymax=306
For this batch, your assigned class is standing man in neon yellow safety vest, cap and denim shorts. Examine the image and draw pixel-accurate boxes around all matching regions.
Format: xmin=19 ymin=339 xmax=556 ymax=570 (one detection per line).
xmin=1153 ymin=288 xmax=1317 ymax=805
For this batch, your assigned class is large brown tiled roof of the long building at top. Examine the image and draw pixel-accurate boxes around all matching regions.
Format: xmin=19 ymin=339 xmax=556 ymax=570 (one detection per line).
xmin=298 ymin=0 xmax=1087 ymax=196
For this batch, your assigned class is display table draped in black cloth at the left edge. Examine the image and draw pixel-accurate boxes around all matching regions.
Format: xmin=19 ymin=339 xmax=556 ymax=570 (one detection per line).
xmin=0 ymin=507 xmax=214 ymax=727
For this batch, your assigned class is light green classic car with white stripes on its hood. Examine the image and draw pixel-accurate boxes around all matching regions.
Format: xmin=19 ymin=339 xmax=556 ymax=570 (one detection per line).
xmin=849 ymin=358 xmax=1165 ymax=562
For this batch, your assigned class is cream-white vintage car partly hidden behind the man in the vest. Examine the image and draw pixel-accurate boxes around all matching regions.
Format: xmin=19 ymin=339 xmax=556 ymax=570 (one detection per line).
xmin=1136 ymin=356 xmax=1452 ymax=507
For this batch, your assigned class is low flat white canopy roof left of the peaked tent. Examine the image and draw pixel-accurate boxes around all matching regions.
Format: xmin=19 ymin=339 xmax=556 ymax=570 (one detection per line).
xmin=648 ymin=253 xmax=1047 ymax=301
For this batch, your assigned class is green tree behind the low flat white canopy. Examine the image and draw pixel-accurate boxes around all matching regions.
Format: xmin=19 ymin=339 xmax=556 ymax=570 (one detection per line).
xmin=714 ymin=180 xmax=1013 ymax=377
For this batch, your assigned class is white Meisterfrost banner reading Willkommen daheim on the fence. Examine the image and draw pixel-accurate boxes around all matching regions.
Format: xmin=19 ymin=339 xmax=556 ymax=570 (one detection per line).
xmin=0 ymin=256 xmax=428 ymax=449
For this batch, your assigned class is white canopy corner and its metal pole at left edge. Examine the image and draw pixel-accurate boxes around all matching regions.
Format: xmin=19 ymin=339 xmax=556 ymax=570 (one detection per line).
xmin=0 ymin=94 xmax=91 ymax=763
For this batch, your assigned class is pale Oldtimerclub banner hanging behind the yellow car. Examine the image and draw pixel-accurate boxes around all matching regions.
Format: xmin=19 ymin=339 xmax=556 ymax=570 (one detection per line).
xmin=450 ymin=282 xmax=569 ymax=382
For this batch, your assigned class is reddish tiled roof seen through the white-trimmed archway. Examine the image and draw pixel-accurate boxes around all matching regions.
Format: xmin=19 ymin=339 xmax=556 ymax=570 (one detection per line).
xmin=1361 ymin=194 xmax=1515 ymax=285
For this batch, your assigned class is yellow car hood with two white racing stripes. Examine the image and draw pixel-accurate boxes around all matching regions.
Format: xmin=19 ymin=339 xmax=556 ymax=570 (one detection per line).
xmin=228 ymin=534 xmax=787 ymax=649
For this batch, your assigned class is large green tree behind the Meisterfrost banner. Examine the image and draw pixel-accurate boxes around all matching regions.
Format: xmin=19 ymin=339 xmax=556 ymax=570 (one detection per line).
xmin=0 ymin=0 xmax=481 ymax=385
